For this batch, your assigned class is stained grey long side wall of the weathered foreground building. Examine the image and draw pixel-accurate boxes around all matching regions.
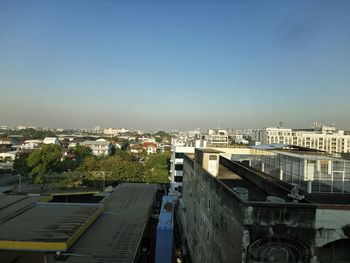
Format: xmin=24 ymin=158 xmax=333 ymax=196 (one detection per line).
xmin=180 ymin=157 xmax=243 ymax=263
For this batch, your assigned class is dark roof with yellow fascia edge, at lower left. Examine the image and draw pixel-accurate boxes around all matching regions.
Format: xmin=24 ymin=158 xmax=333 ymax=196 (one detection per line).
xmin=0 ymin=201 xmax=103 ymax=251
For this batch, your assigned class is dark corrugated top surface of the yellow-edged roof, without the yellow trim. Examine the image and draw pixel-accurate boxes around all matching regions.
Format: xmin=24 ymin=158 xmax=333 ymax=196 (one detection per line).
xmin=0 ymin=202 xmax=101 ymax=250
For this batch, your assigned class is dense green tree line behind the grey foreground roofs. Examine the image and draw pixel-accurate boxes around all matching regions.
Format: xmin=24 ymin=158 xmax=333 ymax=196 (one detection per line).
xmin=14 ymin=144 xmax=170 ymax=190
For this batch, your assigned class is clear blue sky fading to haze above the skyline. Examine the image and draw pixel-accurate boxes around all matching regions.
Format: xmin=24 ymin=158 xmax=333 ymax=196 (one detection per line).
xmin=0 ymin=0 xmax=350 ymax=130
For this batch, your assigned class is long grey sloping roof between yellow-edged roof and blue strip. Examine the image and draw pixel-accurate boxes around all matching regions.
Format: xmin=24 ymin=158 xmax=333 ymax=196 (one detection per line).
xmin=55 ymin=183 xmax=159 ymax=263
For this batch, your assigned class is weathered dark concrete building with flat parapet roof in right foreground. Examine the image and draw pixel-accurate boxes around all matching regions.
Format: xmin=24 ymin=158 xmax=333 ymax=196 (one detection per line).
xmin=176 ymin=149 xmax=350 ymax=263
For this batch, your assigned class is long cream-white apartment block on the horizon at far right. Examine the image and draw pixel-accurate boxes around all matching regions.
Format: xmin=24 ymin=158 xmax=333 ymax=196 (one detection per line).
xmin=253 ymin=126 xmax=350 ymax=153
